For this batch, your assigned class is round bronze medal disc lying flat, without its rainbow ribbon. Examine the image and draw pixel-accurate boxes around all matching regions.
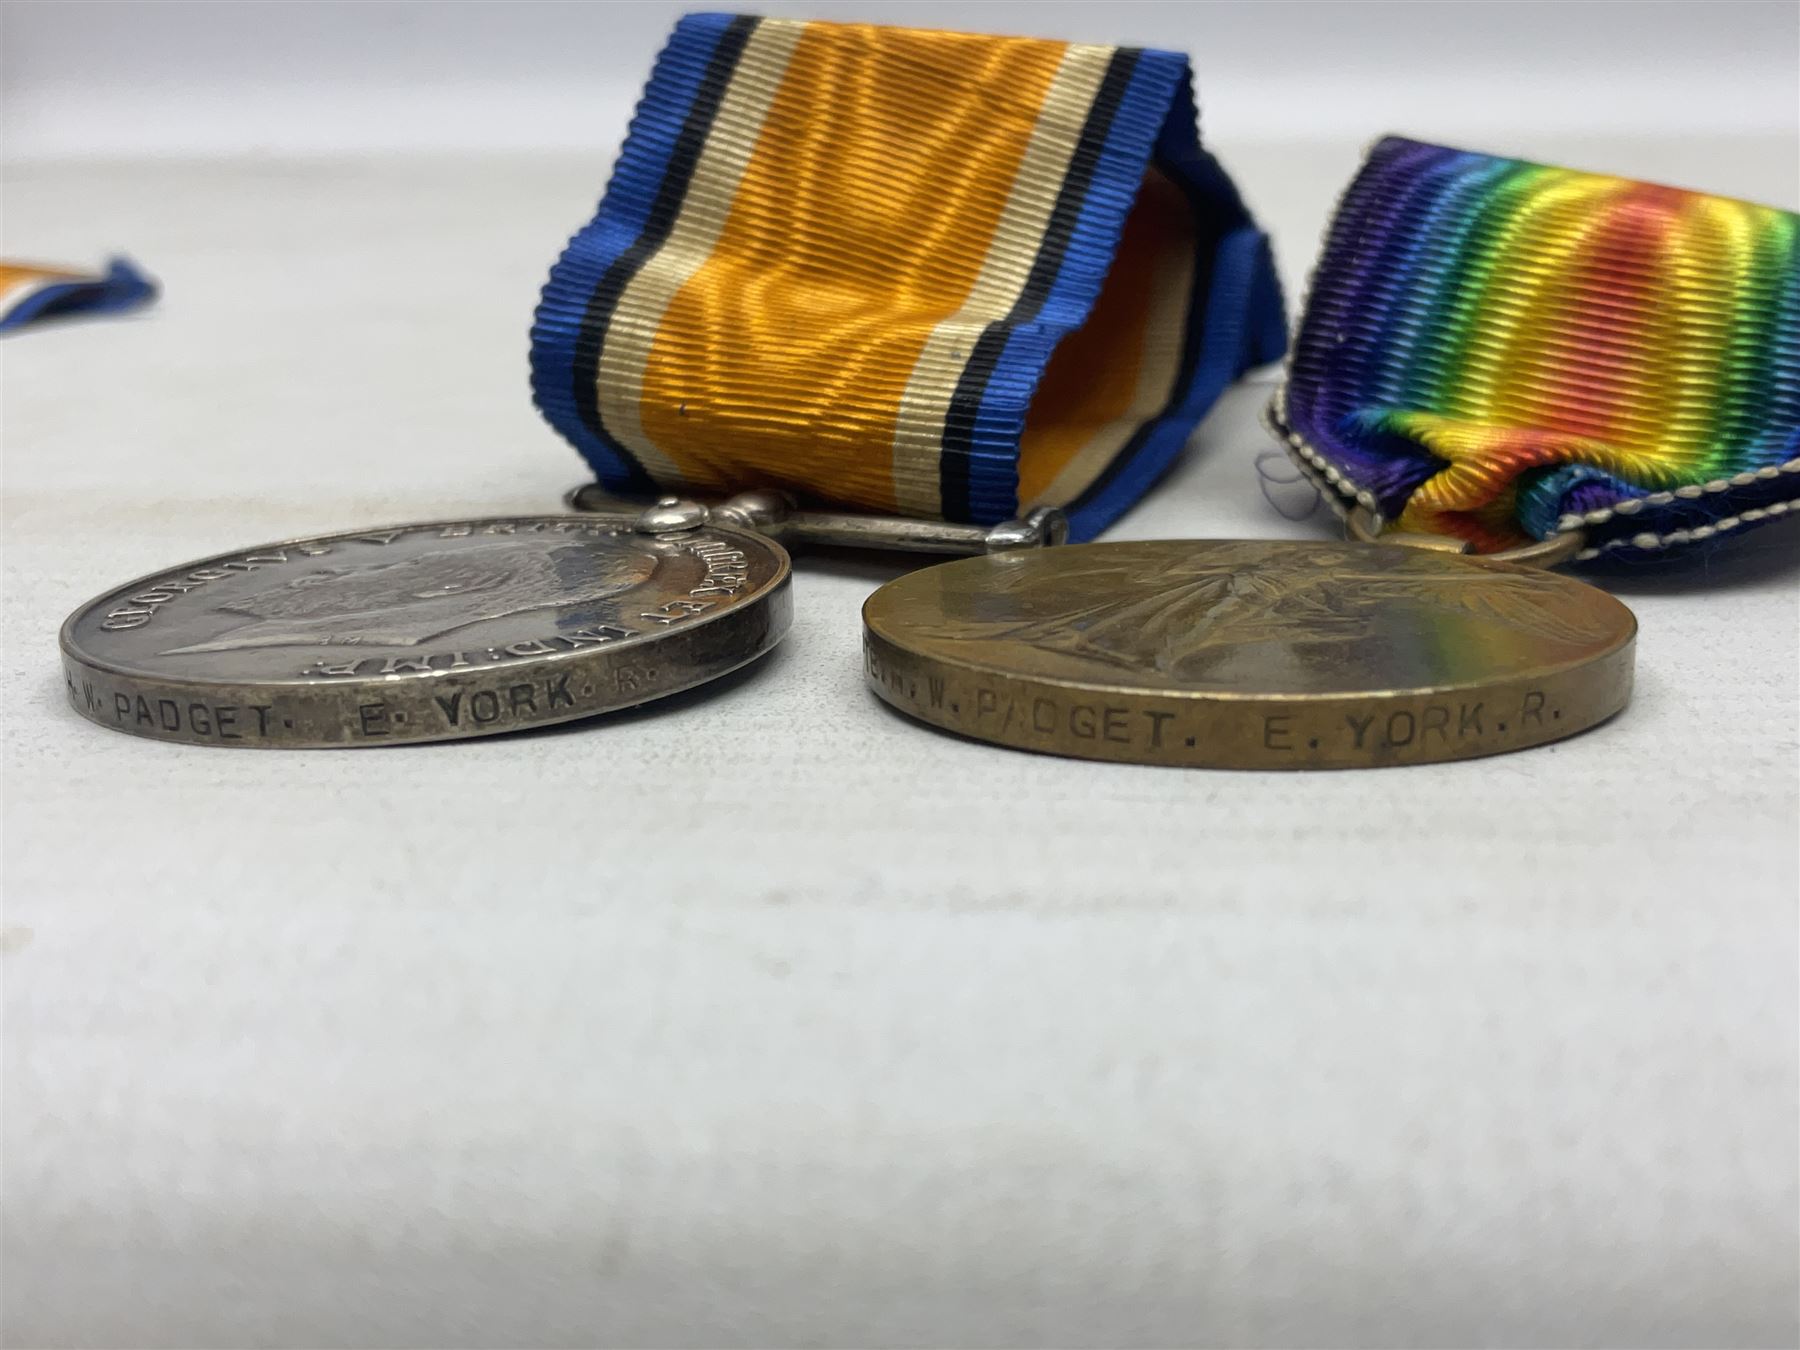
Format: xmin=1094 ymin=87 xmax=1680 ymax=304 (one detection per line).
xmin=862 ymin=540 xmax=1636 ymax=769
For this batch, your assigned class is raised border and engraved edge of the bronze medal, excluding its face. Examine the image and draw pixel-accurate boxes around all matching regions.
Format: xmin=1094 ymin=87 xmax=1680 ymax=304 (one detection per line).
xmin=862 ymin=540 xmax=1636 ymax=769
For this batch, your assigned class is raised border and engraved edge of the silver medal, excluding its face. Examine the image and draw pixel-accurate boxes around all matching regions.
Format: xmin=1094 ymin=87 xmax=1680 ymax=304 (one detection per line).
xmin=58 ymin=515 xmax=792 ymax=749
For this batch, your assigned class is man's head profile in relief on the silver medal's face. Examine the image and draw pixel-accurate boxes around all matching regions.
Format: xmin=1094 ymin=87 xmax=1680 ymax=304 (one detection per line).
xmin=162 ymin=536 xmax=657 ymax=655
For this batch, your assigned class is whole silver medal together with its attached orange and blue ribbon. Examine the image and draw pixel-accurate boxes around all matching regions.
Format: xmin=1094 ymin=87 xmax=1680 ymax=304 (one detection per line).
xmin=63 ymin=14 xmax=1285 ymax=745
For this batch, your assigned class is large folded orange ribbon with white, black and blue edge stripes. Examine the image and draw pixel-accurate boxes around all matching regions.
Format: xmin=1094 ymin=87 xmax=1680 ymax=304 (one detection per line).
xmin=531 ymin=14 xmax=1285 ymax=538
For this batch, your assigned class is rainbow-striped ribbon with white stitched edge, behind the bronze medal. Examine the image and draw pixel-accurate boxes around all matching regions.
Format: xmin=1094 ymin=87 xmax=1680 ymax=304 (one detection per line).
xmin=1271 ymin=139 xmax=1800 ymax=558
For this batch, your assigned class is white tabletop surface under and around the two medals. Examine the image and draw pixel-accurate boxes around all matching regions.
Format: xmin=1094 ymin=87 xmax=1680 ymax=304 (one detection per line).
xmin=0 ymin=11 xmax=1800 ymax=1346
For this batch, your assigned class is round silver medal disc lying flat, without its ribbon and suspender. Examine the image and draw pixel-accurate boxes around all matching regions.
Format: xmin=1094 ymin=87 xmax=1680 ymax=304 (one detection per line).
xmin=61 ymin=517 xmax=790 ymax=747
